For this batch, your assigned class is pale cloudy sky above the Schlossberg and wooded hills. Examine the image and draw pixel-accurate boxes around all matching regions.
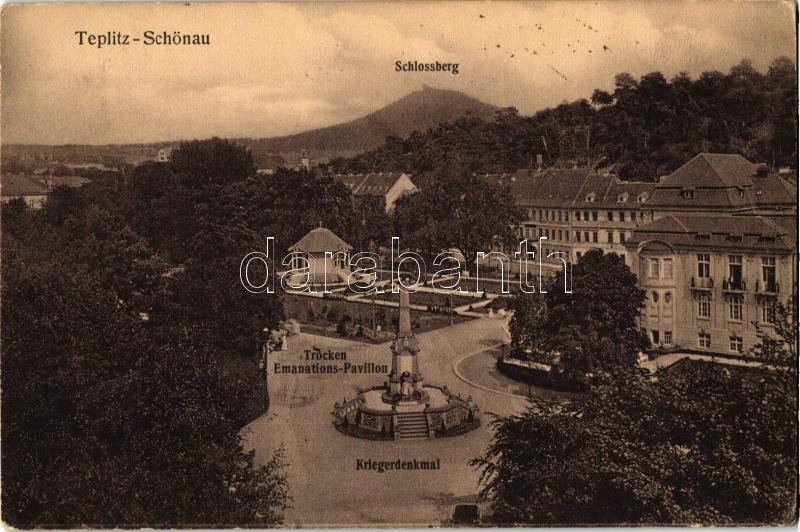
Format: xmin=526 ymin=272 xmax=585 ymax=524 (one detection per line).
xmin=0 ymin=0 xmax=796 ymax=144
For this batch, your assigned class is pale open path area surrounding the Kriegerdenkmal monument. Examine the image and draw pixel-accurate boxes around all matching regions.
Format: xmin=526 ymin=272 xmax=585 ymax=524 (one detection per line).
xmin=242 ymin=318 xmax=527 ymax=527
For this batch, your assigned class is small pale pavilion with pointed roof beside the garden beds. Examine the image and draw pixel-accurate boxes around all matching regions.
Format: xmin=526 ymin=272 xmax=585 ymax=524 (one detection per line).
xmin=289 ymin=227 xmax=353 ymax=286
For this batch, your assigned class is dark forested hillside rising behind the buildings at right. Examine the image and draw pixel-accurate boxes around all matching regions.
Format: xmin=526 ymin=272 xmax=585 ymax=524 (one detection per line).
xmin=332 ymin=58 xmax=797 ymax=180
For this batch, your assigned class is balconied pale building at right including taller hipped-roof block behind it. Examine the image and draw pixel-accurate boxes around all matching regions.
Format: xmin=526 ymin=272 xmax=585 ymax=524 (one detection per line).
xmin=625 ymin=153 xmax=797 ymax=355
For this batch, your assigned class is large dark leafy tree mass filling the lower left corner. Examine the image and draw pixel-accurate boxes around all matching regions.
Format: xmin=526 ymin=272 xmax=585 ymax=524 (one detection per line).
xmin=2 ymin=246 xmax=287 ymax=527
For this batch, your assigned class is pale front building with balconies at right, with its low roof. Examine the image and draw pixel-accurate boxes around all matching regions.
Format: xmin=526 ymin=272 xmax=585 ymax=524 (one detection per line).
xmin=626 ymin=214 xmax=797 ymax=355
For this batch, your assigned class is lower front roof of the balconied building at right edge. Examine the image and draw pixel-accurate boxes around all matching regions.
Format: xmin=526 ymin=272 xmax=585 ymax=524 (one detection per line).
xmin=625 ymin=214 xmax=796 ymax=252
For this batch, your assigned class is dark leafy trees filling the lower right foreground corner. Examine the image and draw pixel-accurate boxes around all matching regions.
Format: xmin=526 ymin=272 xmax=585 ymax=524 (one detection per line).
xmin=472 ymin=361 xmax=797 ymax=526
